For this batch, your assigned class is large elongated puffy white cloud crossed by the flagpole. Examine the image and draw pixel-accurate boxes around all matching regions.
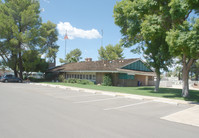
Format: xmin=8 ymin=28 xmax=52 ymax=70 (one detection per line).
xmin=57 ymin=22 xmax=102 ymax=39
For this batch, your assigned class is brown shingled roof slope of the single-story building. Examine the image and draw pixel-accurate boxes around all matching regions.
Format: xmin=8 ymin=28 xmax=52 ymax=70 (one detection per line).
xmin=49 ymin=58 xmax=138 ymax=72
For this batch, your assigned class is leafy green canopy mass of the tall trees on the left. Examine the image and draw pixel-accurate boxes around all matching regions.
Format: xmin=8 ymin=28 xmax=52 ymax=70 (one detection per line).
xmin=0 ymin=0 xmax=59 ymax=78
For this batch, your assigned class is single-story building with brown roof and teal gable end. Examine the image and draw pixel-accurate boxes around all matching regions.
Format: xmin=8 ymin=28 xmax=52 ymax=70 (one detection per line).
xmin=47 ymin=58 xmax=155 ymax=86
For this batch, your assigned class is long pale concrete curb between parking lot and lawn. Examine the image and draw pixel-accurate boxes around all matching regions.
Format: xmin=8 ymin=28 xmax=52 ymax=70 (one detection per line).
xmin=29 ymin=83 xmax=198 ymax=106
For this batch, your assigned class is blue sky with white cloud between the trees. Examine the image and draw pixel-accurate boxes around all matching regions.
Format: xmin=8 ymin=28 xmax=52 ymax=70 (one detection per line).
xmin=40 ymin=0 xmax=140 ymax=65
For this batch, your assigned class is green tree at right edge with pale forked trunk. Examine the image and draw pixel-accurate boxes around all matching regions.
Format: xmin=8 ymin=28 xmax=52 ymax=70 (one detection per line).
xmin=166 ymin=0 xmax=199 ymax=97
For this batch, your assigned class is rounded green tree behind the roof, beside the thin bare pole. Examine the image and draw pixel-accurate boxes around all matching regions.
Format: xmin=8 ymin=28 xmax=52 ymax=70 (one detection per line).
xmin=98 ymin=44 xmax=124 ymax=60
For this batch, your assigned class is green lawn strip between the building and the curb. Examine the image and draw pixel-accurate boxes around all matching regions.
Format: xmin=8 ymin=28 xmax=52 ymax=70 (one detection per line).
xmin=44 ymin=82 xmax=199 ymax=102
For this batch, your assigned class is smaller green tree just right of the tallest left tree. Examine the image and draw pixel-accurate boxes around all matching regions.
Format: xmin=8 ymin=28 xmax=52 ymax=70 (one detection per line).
xmin=40 ymin=21 xmax=59 ymax=63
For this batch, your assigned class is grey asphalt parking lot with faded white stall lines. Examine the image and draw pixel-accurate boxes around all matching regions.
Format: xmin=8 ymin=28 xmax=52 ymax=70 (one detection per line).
xmin=0 ymin=83 xmax=199 ymax=138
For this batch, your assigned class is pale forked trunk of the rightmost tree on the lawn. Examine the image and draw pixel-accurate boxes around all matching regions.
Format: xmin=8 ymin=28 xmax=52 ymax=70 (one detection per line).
xmin=182 ymin=55 xmax=195 ymax=97
